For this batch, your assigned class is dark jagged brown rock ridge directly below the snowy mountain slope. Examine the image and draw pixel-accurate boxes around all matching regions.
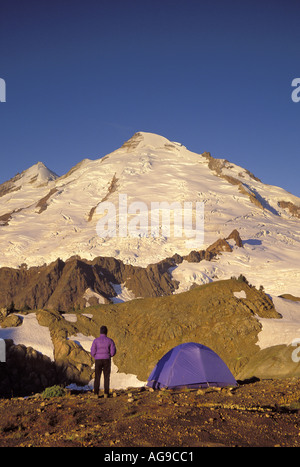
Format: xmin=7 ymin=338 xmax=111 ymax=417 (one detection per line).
xmin=0 ymin=230 xmax=242 ymax=311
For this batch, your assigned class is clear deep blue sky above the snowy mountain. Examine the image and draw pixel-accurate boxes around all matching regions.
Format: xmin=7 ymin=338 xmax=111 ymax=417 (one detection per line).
xmin=0 ymin=0 xmax=300 ymax=196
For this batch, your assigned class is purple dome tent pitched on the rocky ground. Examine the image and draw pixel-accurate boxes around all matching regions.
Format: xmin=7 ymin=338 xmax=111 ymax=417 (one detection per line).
xmin=147 ymin=342 xmax=237 ymax=389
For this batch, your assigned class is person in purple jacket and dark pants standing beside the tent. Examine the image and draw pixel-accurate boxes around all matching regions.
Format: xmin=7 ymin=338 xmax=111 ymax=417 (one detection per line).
xmin=91 ymin=326 xmax=116 ymax=398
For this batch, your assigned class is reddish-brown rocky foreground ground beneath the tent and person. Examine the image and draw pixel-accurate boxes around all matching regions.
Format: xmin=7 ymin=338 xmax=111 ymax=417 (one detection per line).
xmin=0 ymin=378 xmax=300 ymax=449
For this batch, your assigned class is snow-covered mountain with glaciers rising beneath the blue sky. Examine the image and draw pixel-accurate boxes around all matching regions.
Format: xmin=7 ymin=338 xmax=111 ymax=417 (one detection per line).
xmin=0 ymin=132 xmax=300 ymax=296
